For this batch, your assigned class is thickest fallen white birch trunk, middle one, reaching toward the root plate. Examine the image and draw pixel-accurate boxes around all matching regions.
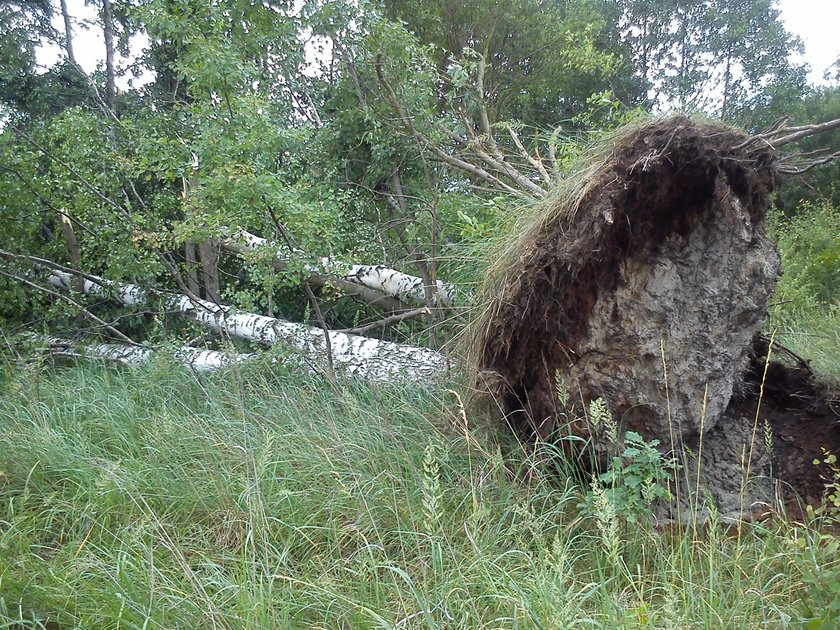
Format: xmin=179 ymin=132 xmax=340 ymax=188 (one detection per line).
xmin=48 ymin=271 xmax=446 ymax=381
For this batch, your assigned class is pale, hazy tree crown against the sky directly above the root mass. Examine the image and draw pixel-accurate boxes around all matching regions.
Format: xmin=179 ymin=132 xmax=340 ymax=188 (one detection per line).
xmin=601 ymin=0 xmax=806 ymax=124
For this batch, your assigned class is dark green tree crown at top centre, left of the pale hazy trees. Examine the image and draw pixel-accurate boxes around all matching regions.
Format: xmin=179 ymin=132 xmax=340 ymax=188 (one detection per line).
xmin=384 ymin=0 xmax=618 ymax=127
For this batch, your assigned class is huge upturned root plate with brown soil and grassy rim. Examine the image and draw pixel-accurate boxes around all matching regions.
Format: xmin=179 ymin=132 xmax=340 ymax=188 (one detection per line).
xmin=470 ymin=115 xmax=840 ymax=511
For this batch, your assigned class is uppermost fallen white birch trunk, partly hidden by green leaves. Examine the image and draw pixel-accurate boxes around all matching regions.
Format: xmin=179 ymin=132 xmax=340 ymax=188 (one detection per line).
xmin=234 ymin=230 xmax=455 ymax=304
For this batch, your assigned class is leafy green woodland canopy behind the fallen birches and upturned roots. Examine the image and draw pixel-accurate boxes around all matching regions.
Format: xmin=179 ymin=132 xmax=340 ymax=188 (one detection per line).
xmin=0 ymin=0 xmax=838 ymax=345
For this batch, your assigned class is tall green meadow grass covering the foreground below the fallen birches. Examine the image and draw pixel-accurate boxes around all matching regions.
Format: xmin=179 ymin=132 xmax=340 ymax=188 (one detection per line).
xmin=0 ymin=361 xmax=840 ymax=629
